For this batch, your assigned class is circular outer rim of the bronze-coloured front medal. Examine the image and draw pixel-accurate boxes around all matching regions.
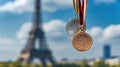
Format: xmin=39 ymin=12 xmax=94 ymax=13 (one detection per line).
xmin=72 ymin=31 xmax=93 ymax=52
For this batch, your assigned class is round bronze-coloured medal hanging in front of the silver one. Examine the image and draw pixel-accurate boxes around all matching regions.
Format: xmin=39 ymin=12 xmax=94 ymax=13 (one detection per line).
xmin=72 ymin=31 xmax=93 ymax=52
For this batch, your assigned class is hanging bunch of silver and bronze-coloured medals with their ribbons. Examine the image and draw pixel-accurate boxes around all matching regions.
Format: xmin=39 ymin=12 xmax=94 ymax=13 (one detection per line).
xmin=66 ymin=0 xmax=93 ymax=52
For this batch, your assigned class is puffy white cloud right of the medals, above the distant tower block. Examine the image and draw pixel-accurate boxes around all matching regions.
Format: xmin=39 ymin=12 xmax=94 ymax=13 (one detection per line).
xmin=88 ymin=24 xmax=120 ymax=43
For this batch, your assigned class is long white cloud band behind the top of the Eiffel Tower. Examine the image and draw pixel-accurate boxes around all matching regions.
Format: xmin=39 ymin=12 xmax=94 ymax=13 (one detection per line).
xmin=0 ymin=0 xmax=72 ymax=13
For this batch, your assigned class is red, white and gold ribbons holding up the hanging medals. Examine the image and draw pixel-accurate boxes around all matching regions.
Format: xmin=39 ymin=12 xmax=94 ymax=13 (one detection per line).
xmin=73 ymin=0 xmax=88 ymax=25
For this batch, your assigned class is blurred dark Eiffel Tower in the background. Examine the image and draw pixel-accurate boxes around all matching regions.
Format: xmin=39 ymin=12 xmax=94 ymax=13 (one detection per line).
xmin=18 ymin=0 xmax=56 ymax=67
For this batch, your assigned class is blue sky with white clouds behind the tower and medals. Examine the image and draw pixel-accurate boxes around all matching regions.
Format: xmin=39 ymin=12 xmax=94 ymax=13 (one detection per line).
xmin=0 ymin=0 xmax=120 ymax=61
